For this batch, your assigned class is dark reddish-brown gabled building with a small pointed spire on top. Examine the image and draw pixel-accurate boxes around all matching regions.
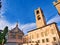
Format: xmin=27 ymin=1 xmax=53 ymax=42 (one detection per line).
xmin=6 ymin=24 xmax=24 ymax=45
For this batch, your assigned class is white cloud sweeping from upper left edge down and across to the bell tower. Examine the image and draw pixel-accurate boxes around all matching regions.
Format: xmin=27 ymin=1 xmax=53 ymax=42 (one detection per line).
xmin=0 ymin=0 xmax=36 ymax=33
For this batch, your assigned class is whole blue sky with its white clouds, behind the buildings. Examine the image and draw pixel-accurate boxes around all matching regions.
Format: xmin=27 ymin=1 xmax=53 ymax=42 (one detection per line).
xmin=0 ymin=0 xmax=60 ymax=32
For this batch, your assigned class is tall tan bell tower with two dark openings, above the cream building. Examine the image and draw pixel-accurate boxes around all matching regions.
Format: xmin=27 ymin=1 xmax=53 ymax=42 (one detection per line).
xmin=35 ymin=8 xmax=46 ymax=28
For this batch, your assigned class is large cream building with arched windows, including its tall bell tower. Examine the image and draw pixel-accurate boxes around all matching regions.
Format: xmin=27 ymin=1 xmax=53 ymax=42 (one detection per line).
xmin=23 ymin=8 xmax=60 ymax=45
